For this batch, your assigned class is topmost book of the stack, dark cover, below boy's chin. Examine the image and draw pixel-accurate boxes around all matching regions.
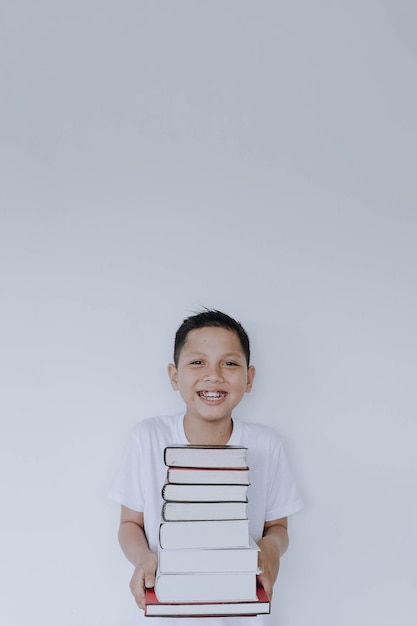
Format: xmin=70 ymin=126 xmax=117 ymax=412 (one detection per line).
xmin=164 ymin=445 xmax=247 ymax=468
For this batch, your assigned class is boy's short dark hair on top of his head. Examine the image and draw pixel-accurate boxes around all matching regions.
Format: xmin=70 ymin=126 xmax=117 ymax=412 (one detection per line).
xmin=174 ymin=309 xmax=250 ymax=366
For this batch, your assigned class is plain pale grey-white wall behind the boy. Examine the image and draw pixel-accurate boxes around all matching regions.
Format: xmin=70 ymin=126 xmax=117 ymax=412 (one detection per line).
xmin=0 ymin=0 xmax=417 ymax=626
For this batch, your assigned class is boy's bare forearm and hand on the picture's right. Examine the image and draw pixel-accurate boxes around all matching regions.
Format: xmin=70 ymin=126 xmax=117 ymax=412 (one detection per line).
xmin=258 ymin=517 xmax=288 ymax=599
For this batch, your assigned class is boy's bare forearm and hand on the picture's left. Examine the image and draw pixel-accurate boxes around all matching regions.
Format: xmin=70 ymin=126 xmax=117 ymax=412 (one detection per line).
xmin=119 ymin=506 xmax=158 ymax=609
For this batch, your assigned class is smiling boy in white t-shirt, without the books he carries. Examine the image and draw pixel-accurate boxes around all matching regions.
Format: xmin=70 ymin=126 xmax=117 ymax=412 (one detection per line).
xmin=110 ymin=310 xmax=302 ymax=626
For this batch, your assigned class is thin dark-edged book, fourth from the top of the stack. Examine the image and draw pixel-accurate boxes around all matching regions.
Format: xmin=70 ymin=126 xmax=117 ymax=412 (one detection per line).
xmin=162 ymin=502 xmax=247 ymax=522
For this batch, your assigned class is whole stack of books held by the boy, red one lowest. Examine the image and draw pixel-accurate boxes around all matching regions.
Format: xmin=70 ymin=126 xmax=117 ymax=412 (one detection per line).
xmin=145 ymin=445 xmax=270 ymax=617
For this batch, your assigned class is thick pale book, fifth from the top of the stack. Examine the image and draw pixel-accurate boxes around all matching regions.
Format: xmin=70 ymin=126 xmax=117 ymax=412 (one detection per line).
xmin=159 ymin=519 xmax=250 ymax=549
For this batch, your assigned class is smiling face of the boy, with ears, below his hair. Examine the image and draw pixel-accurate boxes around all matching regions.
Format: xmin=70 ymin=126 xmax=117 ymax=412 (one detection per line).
xmin=168 ymin=326 xmax=255 ymax=422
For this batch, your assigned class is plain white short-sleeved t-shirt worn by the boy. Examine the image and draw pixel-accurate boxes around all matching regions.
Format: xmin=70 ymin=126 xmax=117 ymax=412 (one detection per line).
xmin=109 ymin=413 xmax=303 ymax=626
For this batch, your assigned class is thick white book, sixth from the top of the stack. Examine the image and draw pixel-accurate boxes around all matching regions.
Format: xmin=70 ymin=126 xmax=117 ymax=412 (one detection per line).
xmin=158 ymin=539 xmax=259 ymax=574
